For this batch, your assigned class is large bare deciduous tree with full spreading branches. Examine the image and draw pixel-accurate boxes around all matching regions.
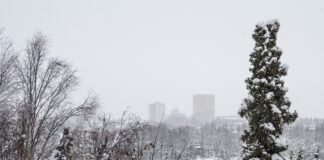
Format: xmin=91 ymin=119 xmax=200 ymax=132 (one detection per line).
xmin=12 ymin=33 xmax=97 ymax=160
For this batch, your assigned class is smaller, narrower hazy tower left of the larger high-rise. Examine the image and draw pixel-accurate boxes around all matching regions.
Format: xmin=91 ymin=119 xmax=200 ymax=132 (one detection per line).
xmin=149 ymin=102 xmax=165 ymax=122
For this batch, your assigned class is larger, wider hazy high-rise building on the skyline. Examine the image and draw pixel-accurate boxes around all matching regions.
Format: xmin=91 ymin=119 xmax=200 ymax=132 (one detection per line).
xmin=192 ymin=94 xmax=215 ymax=122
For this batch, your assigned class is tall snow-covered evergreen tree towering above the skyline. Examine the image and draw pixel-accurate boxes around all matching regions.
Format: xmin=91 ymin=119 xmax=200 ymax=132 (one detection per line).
xmin=239 ymin=20 xmax=297 ymax=160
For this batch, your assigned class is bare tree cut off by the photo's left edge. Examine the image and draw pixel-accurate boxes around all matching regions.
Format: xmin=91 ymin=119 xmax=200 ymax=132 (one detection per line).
xmin=0 ymin=30 xmax=17 ymax=159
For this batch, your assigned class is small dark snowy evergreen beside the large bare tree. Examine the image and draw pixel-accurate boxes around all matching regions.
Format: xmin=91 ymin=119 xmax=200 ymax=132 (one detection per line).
xmin=55 ymin=128 xmax=73 ymax=160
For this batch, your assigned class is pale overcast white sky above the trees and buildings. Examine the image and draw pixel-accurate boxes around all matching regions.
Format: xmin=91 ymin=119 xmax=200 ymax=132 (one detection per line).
xmin=0 ymin=0 xmax=324 ymax=118
